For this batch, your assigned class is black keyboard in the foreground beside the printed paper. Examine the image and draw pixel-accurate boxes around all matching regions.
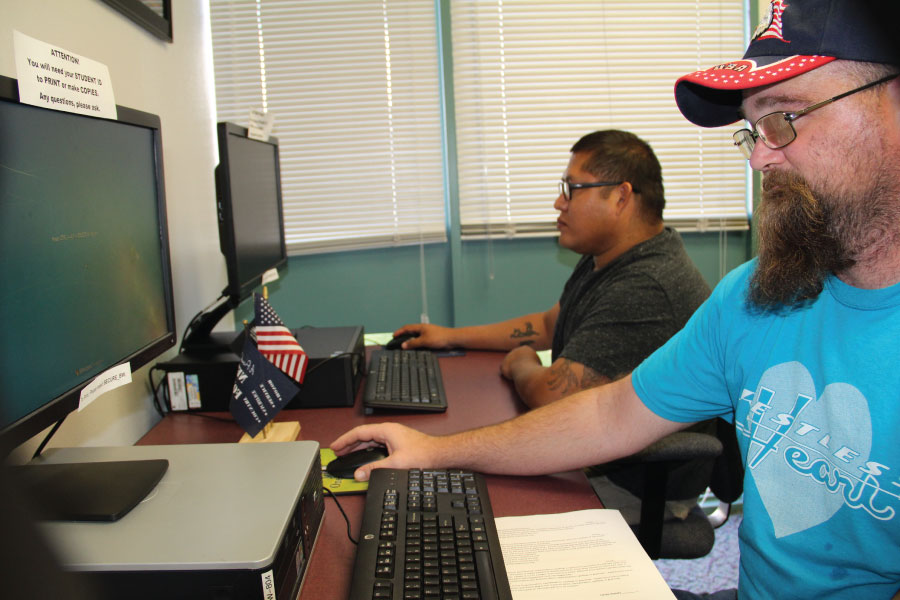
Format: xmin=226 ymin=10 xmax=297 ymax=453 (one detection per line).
xmin=350 ymin=469 xmax=512 ymax=600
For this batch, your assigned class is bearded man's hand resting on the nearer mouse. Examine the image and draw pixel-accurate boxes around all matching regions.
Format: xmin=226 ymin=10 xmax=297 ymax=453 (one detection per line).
xmin=331 ymin=423 xmax=440 ymax=481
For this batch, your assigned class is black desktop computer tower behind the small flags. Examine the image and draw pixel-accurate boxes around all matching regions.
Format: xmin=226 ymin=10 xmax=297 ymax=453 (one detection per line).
xmin=155 ymin=325 xmax=366 ymax=412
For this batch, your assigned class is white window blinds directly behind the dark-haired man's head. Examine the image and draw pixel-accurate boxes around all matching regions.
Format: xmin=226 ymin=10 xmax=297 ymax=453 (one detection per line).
xmin=451 ymin=0 xmax=747 ymax=236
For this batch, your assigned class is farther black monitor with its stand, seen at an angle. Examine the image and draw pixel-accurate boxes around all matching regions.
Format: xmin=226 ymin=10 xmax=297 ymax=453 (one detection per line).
xmin=182 ymin=122 xmax=287 ymax=353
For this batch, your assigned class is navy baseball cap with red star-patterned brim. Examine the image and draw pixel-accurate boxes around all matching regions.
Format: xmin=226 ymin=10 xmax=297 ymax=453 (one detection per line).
xmin=675 ymin=0 xmax=900 ymax=127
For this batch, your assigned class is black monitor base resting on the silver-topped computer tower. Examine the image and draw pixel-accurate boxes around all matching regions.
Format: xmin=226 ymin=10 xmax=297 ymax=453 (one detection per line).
xmin=10 ymin=459 xmax=169 ymax=521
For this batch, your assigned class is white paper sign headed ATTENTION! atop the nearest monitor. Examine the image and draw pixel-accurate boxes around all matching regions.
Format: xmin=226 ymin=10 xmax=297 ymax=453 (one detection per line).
xmin=13 ymin=31 xmax=117 ymax=119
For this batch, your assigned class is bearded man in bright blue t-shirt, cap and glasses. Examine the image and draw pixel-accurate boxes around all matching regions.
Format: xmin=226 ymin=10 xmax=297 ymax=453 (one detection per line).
xmin=333 ymin=0 xmax=900 ymax=600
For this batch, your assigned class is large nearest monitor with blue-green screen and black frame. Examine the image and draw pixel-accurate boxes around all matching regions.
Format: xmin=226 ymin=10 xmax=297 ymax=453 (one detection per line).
xmin=0 ymin=77 xmax=176 ymax=458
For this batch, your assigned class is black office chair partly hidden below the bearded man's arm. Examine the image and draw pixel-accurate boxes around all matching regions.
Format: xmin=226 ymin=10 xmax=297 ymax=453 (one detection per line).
xmin=588 ymin=419 xmax=744 ymax=560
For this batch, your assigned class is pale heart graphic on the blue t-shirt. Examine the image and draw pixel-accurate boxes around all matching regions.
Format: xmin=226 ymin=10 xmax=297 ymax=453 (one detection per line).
xmin=747 ymin=362 xmax=872 ymax=538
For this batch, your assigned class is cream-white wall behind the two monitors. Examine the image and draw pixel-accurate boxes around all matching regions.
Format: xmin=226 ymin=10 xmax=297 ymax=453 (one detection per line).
xmin=0 ymin=0 xmax=226 ymax=460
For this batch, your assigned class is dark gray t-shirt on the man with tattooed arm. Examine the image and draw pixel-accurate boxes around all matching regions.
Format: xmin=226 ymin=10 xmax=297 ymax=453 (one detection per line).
xmin=552 ymin=228 xmax=710 ymax=379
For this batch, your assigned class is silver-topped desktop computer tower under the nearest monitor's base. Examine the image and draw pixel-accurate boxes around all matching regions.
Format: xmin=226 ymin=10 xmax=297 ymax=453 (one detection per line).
xmin=37 ymin=442 xmax=325 ymax=600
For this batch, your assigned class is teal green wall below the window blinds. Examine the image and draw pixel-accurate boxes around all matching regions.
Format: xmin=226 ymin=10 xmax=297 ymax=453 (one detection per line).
xmin=235 ymin=231 xmax=751 ymax=333
